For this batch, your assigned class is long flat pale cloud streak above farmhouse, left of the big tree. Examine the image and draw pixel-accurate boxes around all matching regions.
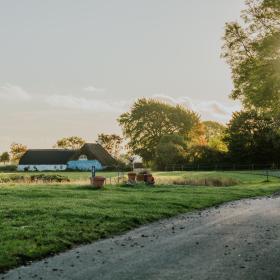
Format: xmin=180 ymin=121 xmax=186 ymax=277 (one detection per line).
xmin=45 ymin=95 xmax=126 ymax=113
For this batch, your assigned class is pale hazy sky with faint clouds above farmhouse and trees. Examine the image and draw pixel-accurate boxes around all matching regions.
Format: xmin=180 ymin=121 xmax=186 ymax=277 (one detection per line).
xmin=0 ymin=0 xmax=244 ymax=151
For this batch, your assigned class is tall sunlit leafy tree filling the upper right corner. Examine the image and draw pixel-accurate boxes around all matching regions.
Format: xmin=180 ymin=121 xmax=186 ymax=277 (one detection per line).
xmin=222 ymin=0 xmax=280 ymax=114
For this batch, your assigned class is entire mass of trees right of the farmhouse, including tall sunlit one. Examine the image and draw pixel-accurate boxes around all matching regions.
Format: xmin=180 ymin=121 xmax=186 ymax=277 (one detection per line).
xmin=119 ymin=0 xmax=280 ymax=169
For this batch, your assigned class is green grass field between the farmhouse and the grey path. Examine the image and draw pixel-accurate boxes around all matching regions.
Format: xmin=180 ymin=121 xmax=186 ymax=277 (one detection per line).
xmin=0 ymin=172 xmax=280 ymax=271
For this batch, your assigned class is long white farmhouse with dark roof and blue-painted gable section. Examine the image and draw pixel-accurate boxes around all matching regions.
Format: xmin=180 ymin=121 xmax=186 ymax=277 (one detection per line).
xmin=18 ymin=144 xmax=116 ymax=171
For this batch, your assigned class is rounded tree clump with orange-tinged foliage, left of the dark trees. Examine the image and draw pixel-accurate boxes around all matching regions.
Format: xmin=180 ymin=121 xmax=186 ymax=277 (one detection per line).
xmin=118 ymin=98 xmax=227 ymax=169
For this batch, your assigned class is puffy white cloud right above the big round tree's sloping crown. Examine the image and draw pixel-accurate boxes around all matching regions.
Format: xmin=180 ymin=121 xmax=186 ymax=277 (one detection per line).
xmin=153 ymin=94 xmax=240 ymax=123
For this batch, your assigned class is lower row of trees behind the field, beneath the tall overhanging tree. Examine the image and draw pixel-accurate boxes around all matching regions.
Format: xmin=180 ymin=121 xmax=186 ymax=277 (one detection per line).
xmin=119 ymin=99 xmax=280 ymax=170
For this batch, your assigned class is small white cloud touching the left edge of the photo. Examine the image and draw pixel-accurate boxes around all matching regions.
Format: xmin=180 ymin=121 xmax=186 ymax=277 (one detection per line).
xmin=0 ymin=84 xmax=31 ymax=101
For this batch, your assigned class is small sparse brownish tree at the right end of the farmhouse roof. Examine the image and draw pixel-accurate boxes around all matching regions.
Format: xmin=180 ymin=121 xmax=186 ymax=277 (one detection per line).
xmin=97 ymin=133 xmax=123 ymax=158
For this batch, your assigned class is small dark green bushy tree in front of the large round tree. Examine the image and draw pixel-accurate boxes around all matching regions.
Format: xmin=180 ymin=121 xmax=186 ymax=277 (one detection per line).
xmin=155 ymin=134 xmax=187 ymax=170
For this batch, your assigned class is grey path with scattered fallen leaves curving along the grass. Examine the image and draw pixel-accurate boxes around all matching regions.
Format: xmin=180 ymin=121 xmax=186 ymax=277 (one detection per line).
xmin=0 ymin=197 xmax=280 ymax=280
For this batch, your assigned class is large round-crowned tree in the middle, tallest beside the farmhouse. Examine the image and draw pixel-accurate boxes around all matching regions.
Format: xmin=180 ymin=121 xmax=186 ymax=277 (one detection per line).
xmin=118 ymin=98 xmax=199 ymax=162
